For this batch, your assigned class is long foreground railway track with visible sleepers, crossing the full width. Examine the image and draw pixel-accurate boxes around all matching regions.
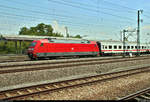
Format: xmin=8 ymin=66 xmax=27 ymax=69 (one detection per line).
xmin=0 ymin=66 xmax=150 ymax=100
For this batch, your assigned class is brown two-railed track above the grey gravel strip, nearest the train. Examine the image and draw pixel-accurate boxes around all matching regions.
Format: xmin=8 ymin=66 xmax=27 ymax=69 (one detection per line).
xmin=0 ymin=57 xmax=150 ymax=74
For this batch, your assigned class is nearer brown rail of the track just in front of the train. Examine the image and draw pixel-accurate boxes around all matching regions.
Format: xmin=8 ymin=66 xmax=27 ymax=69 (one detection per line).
xmin=0 ymin=58 xmax=150 ymax=74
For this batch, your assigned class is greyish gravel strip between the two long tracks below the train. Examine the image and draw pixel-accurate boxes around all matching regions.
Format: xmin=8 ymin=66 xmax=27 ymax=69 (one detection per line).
xmin=0 ymin=59 xmax=150 ymax=91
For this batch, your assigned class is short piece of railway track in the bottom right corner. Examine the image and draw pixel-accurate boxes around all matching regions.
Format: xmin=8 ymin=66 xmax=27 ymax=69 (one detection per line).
xmin=119 ymin=87 xmax=150 ymax=102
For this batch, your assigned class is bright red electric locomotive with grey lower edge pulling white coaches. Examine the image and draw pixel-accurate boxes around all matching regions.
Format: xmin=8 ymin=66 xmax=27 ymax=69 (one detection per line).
xmin=28 ymin=39 xmax=99 ymax=59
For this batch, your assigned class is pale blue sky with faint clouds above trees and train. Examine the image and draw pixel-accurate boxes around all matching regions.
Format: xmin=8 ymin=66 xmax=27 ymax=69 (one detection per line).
xmin=0 ymin=0 xmax=150 ymax=42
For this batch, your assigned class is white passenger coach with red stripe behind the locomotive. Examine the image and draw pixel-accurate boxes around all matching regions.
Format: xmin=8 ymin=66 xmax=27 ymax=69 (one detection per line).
xmin=98 ymin=40 xmax=150 ymax=54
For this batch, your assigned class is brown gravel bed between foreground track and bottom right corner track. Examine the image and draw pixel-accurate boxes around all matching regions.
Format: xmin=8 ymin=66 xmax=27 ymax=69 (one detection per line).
xmin=23 ymin=72 xmax=150 ymax=100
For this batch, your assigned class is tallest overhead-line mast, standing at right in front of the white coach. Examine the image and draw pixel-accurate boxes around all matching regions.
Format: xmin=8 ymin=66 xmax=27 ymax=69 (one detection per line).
xmin=137 ymin=10 xmax=143 ymax=56
